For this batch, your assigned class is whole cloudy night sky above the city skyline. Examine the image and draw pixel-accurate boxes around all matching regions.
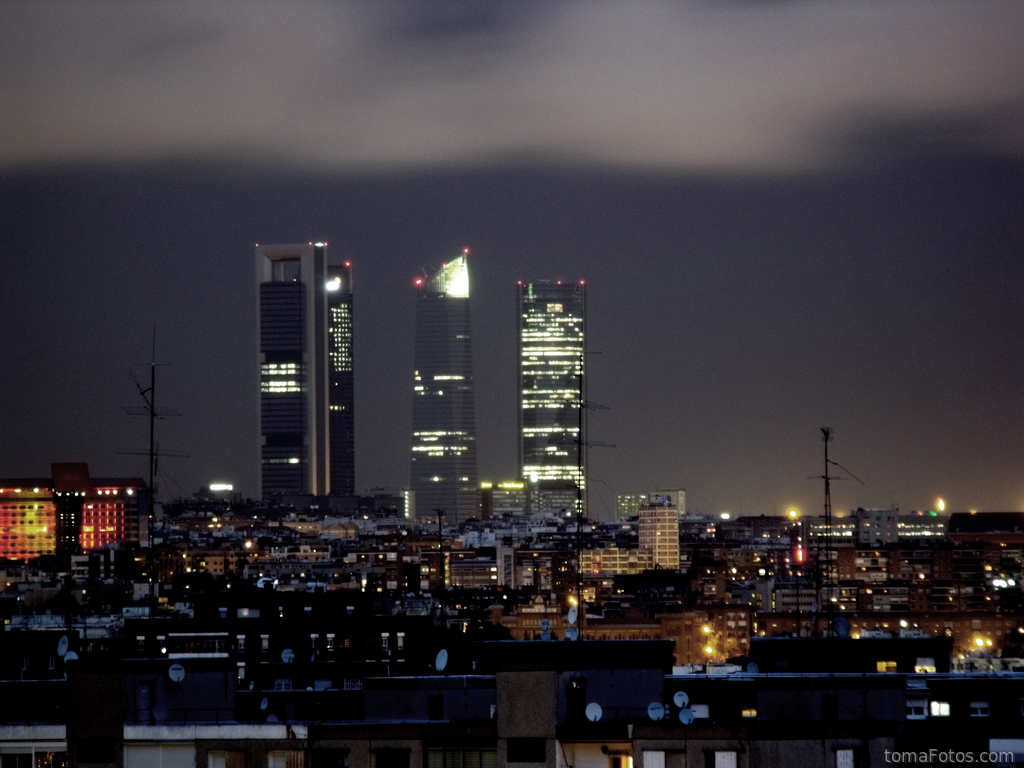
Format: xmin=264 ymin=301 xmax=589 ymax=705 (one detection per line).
xmin=0 ymin=0 xmax=1024 ymax=517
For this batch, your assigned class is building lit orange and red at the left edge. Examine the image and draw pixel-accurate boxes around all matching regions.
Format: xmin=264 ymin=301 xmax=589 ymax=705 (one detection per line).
xmin=0 ymin=464 xmax=145 ymax=560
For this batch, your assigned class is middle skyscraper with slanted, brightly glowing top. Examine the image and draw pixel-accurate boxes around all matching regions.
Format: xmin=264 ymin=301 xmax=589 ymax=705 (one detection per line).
xmin=411 ymin=251 xmax=477 ymax=523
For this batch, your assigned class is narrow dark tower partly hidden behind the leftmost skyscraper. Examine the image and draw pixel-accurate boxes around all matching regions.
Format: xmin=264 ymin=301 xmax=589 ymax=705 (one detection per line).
xmin=327 ymin=261 xmax=355 ymax=497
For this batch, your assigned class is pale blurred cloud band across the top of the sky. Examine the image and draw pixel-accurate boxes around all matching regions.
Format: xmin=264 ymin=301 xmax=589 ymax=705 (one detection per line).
xmin=0 ymin=0 xmax=1024 ymax=171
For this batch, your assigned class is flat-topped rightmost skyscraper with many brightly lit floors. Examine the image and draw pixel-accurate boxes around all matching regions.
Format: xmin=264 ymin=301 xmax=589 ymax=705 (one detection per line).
xmin=518 ymin=281 xmax=587 ymax=510
